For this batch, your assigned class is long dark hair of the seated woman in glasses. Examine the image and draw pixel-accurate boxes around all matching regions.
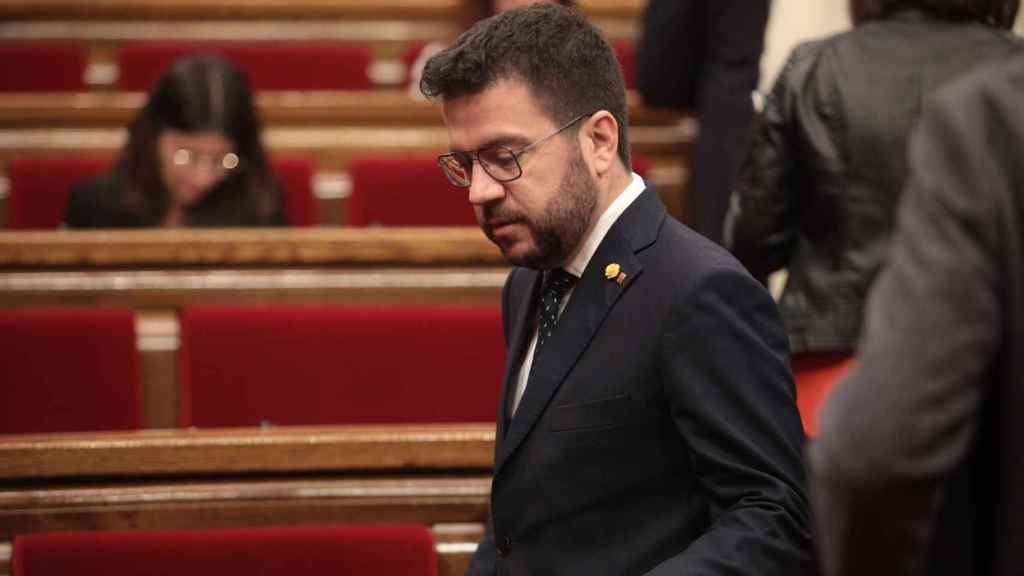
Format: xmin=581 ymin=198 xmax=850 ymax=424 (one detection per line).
xmin=114 ymin=55 xmax=282 ymax=227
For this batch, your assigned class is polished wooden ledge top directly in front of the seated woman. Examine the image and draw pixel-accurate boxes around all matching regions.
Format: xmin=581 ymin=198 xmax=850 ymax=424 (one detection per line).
xmin=0 ymin=227 xmax=504 ymax=270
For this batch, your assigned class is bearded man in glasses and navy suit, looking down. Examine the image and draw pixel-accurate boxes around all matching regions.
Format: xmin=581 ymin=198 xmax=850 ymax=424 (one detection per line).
xmin=421 ymin=4 xmax=812 ymax=576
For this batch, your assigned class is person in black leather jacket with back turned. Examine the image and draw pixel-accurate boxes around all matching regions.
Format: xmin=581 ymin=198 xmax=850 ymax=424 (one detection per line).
xmin=725 ymin=0 xmax=1024 ymax=354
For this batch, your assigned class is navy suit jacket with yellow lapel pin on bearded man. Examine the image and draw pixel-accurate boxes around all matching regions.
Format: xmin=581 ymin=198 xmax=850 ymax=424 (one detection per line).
xmin=469 ymin=189 xmax=812 ymax=576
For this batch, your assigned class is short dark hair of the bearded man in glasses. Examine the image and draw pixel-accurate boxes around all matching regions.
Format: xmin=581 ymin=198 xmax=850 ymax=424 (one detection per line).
xmin=420 ymin=4 xmax=630 ymax=168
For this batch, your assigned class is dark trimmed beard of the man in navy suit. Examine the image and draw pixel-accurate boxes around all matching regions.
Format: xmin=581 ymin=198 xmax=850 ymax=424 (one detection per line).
xmin=481 ymin=148 xmax=597 ymax=270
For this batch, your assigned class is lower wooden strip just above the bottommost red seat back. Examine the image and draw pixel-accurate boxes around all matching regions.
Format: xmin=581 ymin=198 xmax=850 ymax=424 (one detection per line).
xmin=0 ymin=475 xmax=490 ymax=538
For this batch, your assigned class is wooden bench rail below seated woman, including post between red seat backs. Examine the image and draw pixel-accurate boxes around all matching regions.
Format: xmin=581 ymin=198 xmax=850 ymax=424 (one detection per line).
xmin=0 ymin=228 xmax=508 ymax=427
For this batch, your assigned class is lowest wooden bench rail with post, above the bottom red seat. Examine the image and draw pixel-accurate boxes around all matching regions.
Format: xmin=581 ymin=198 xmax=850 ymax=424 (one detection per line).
xmin=0 ymin=424 xmax=494 ymax=575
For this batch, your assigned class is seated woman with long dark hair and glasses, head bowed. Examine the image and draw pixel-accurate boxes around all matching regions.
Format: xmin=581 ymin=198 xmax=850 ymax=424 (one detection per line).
xmin=66 ymin=56 xmax=286 ymax=229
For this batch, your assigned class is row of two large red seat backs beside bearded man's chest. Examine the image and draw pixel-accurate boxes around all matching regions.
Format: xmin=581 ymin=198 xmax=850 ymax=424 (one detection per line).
xmin=0 ymin=304 xmax=505 ymax=434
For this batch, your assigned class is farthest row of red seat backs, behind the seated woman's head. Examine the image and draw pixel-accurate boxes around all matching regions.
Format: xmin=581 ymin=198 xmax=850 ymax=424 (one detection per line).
xmin=0 ymin=40 xmax=635 ymax=92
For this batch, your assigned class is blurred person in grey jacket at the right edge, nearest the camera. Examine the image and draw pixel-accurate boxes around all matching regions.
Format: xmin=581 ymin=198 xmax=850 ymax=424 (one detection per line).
xmin=810 ymin=58 xmax=1024 ymax=576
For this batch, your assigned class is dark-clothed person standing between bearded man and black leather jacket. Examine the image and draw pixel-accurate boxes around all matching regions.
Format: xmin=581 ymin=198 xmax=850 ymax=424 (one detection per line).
xmin=636 ymin=0 xmax=769 ymax=244
